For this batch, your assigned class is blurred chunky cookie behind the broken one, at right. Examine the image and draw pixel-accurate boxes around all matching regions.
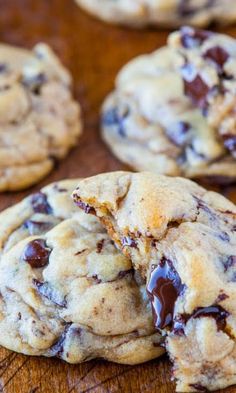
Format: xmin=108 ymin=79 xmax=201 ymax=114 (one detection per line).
xmin=102 ymin=27 xmax=236 ymax=183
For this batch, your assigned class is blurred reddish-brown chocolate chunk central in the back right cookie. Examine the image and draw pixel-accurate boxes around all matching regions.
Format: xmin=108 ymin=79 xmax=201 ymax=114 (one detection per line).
xmin=181 ymin=64 xmax=210 ymax=110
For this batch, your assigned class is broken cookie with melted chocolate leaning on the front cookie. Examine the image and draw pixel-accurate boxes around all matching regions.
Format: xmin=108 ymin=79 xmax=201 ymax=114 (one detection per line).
xmin=74 ymin=172 xmax=236 ymax=392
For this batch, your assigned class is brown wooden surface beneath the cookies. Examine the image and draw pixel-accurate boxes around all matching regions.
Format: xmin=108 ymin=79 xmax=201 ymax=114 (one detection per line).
xmin=0 ymin=0 xmax=236 ymax=393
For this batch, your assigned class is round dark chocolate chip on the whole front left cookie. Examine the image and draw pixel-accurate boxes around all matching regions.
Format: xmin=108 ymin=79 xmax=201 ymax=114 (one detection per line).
xmin=21 ymin=239 xmax=52 ymax=269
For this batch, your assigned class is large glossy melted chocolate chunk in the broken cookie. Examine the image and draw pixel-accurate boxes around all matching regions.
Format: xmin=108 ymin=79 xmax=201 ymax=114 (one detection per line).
xmin=147 ymin=257 xmax=185 ymax=329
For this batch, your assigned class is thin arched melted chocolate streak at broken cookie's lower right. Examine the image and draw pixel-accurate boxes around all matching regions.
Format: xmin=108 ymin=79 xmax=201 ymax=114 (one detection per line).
xmin=173 ymin=305 xmax=229 ymax=335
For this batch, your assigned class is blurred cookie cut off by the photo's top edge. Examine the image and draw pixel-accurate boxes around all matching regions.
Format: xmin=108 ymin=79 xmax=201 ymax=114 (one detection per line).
xmin=76 ymin=0 xmax=236 ymax=27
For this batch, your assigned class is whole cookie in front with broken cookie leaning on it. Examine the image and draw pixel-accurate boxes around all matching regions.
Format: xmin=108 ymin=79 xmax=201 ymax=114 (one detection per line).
xmin=0 ymin=179 xmax=164 ymax=364
